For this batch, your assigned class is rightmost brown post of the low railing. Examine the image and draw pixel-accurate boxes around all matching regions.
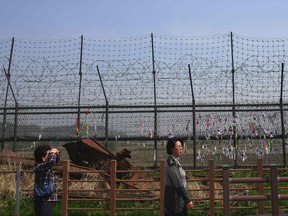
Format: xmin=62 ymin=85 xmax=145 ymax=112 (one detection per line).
xmin=270 ymin=164 xmax=279 ymax=215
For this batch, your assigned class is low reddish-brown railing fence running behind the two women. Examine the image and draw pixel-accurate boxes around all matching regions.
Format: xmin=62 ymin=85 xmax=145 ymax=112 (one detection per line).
xmin=5 ymin=159 xmax=288 ymax=216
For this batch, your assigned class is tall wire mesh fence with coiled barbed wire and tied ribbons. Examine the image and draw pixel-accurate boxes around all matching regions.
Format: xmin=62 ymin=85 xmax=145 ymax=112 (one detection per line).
xmin=0 ymin=33 xmax=288 ymax=167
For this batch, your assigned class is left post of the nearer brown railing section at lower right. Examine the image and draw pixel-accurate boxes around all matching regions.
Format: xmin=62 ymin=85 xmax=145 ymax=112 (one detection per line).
xmin=223 ymin=165 xmax=230 ymax=216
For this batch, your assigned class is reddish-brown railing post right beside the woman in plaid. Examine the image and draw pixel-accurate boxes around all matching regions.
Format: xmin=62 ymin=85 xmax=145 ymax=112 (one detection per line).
xmin=62 ymin=160 xmax=70 ymax=216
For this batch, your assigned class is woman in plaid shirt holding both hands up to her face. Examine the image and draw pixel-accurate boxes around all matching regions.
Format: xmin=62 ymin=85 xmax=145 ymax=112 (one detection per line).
xmin=33 ymin=145 xmax=60 ymax=216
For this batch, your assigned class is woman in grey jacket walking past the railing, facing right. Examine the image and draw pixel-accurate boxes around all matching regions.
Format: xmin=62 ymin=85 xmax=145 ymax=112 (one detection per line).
xmin=164 ymin=137 xmax=193 ymax=216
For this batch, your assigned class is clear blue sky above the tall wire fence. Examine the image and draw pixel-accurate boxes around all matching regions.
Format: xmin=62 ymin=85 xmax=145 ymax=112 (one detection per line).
xmin=0 ymin=0 xmax=288 ymax=40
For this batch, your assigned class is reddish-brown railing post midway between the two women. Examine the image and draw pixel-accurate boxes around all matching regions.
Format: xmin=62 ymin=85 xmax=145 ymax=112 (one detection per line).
xmin=110 ymin=160 xmax=117 ymax=216
